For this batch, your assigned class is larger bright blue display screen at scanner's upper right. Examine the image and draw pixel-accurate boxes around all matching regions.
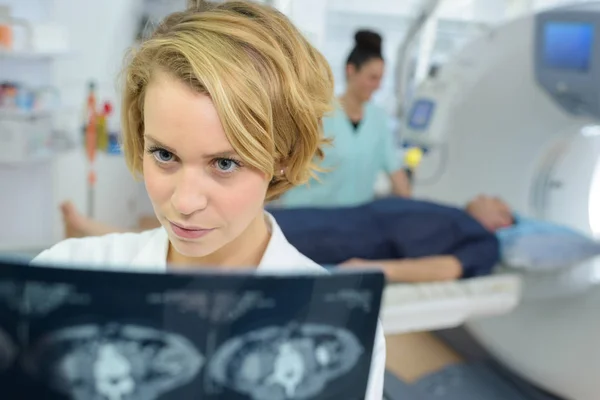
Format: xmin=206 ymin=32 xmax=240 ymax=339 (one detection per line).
xmin=544 ymin=22 xmax=594 ymax=72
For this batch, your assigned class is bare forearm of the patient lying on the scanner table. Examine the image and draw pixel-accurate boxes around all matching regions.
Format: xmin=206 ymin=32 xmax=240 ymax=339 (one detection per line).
xmin=341 ymin=256 xmax=462 ymax=282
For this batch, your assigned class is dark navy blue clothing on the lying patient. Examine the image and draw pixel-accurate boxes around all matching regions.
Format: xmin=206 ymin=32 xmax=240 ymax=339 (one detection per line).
xmin=269 ymin=198 xmax=499 ymax=278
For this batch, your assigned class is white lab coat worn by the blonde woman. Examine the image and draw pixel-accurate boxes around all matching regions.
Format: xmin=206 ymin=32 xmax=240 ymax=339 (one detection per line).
xmin=33 ymin=214 xmax=386 ymax=400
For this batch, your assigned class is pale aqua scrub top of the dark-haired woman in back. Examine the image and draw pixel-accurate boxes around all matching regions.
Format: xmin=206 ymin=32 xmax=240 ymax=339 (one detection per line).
xmin=277 ymin=103 xmax=401 ymax=208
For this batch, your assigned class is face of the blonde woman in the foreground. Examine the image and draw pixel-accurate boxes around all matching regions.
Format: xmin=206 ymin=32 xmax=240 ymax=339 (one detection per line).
xmin=143 ymin=72 xmax=269 ymax=261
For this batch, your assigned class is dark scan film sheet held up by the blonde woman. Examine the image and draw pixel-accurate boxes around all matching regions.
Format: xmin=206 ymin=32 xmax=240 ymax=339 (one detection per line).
xmin=0 ymin=263 xmax=384 ymax=400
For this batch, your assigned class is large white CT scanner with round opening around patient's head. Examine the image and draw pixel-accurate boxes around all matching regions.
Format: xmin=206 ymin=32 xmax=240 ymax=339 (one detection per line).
xmin=394 ymin=2 xmax=600 ymax=400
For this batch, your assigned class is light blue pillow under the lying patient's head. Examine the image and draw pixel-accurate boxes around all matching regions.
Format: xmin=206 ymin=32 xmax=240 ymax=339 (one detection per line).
xmin=496 ymin=216 xmax=600 ymax=270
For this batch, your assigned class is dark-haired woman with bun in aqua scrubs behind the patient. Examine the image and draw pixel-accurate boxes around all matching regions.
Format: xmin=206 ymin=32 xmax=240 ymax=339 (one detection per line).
xmin=277 ymin=30 xmax=410 ymax=208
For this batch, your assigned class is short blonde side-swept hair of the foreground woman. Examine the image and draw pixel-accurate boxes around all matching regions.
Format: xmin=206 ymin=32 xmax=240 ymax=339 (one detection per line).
xmin=122 ymin=1 xmax=333 ymax=200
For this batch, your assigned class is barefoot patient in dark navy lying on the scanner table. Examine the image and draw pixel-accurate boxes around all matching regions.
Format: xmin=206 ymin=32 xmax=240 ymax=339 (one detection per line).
xmin=62 ymin=196 xmax=513 ymax=282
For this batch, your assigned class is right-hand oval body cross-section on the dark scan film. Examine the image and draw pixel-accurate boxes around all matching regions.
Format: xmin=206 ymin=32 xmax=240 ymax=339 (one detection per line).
xmin=208 ymin=324 xmax=363 ymax=400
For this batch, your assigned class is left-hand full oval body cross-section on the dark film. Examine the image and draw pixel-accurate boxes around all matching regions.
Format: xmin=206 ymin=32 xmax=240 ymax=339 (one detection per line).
xmin=24 ymin=324 xmax=204 ymax=400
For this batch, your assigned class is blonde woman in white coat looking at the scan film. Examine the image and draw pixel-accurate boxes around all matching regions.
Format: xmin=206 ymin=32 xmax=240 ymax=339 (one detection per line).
xmin=34 ymin=1 xmax=385 ymax=400
